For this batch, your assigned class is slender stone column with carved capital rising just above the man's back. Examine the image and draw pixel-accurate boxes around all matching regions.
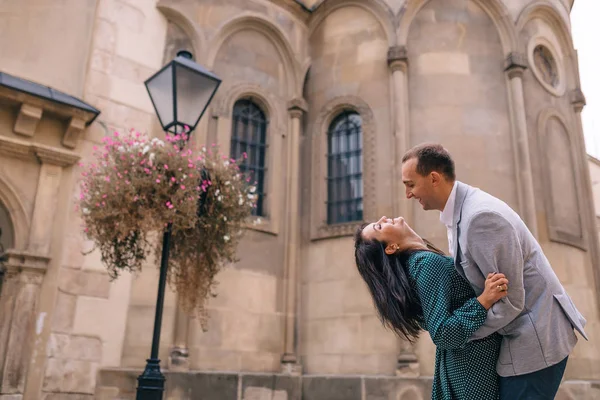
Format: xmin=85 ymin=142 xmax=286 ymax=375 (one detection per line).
xmin=505 ymin=53 xmax=538 ymax=238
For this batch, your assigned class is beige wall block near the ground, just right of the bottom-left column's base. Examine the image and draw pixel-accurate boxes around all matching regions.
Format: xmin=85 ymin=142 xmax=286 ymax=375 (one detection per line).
xmin=42 ymin=358 xmax=98 ymax=394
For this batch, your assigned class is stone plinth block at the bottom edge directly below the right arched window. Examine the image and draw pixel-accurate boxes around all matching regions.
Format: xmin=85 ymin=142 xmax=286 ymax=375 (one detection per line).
xmin=302 ymin=376 xmax=362 ymax=400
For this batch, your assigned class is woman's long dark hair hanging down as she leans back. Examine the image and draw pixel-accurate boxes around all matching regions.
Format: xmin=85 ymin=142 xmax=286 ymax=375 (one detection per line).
xmin=354 ymin=224 xmax=441 ymax=342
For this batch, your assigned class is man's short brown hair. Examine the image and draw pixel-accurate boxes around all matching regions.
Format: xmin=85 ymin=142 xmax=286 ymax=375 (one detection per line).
xmin=402 ymin=143 xmax=456 ymax=182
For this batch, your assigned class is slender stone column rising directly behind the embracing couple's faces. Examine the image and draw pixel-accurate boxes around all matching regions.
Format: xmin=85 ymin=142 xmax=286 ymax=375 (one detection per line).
xmin=388 ymin=46 xmax=419 ymax=377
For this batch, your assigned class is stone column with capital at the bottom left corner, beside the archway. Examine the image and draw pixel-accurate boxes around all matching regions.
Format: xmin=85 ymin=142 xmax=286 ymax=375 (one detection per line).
xmin=0 ymin=250 xmax=50 ymax=399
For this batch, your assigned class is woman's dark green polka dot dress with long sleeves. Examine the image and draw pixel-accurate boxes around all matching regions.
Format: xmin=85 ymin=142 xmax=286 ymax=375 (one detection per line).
xmin=407 ymin=251 xmax=501 ymax=400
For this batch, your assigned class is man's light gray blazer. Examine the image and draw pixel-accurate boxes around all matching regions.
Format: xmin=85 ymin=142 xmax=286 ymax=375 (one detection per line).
xmin=452 ymin=182 xmax=587 ymax=376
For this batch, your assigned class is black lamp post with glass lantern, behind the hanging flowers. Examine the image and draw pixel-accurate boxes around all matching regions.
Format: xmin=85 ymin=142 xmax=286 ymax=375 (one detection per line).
xmin=136 ymin=51 xmax=221 ymax=400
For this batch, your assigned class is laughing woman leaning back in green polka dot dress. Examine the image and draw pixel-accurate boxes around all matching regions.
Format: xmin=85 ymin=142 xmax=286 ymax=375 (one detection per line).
xmin=354 ymin=217 xmax=508 ymax=400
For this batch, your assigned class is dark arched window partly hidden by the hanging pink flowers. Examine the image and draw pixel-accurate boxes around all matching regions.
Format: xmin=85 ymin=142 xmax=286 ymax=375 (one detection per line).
xmin=230 ymin=99 xmax=267 ymax=216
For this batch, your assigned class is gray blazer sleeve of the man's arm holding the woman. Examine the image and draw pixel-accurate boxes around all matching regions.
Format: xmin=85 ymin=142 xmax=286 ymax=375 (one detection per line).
xmin=466 ymin=211 xmax=525 ymax=340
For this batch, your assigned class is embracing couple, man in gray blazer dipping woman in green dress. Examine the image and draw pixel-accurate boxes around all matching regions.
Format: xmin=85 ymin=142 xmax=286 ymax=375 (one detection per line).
xmin=355 ymin=144 xmax=587 ymax=400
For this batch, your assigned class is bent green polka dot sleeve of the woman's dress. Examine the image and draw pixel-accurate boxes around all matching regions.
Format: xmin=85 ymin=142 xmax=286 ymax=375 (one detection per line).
xmin=412 ymin=253 xmax=487 ymax=349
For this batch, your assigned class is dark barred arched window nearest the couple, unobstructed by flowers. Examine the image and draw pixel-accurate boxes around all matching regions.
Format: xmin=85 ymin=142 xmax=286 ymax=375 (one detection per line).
xmin=327 ymin=110 xmax=363 ymax=224
